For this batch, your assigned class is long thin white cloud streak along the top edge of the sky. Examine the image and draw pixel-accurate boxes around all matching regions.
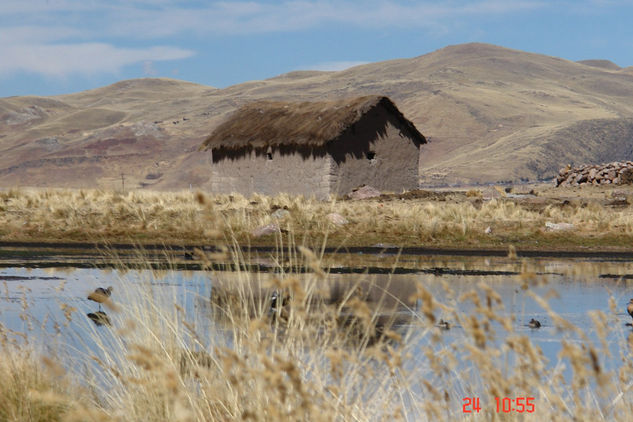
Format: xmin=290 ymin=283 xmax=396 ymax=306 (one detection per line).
xmin=0 ymin=0 xmax=544 ymax=39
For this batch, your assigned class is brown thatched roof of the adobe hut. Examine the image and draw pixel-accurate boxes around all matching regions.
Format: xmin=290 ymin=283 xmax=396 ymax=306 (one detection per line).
xmin=201 ymin=95 xmax=426 ymax=150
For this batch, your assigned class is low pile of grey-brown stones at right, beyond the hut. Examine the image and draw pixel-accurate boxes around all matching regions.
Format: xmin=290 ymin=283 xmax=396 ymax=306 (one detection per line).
xmin=556 ymin=161 xmax=633 ymax=186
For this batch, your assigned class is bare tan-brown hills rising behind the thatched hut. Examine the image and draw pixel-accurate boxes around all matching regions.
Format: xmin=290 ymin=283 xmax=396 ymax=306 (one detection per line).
xmin=0 ymin=43 xmax=633 ymax=189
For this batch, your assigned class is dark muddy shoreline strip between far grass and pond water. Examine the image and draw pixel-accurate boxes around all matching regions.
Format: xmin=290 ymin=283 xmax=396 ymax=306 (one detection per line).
xmin=0 ymin=242 xmax=633 ymax=278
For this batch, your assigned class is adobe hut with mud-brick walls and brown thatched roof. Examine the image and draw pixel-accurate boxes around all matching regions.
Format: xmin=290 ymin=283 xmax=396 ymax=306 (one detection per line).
xmin=201 ymin=96 xmax=426 ymax=198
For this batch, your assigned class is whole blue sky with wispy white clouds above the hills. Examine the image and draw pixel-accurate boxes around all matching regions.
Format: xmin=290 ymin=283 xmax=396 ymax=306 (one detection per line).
xmin=0 ymin=0 xmax=633 ymax=97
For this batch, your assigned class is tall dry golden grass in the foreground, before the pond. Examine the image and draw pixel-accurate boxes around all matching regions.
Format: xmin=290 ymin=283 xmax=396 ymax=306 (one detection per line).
xmin=0 ymin=236 xmax=633 ymax=422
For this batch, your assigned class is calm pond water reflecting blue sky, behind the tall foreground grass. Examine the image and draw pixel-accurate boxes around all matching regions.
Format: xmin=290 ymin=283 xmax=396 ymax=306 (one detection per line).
xmin=0 ymin=257 xmax=632 ymax=369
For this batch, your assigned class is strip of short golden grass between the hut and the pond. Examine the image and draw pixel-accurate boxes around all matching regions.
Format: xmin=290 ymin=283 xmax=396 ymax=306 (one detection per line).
xmin=0 ymin=185 xmax=633 ymax=250
